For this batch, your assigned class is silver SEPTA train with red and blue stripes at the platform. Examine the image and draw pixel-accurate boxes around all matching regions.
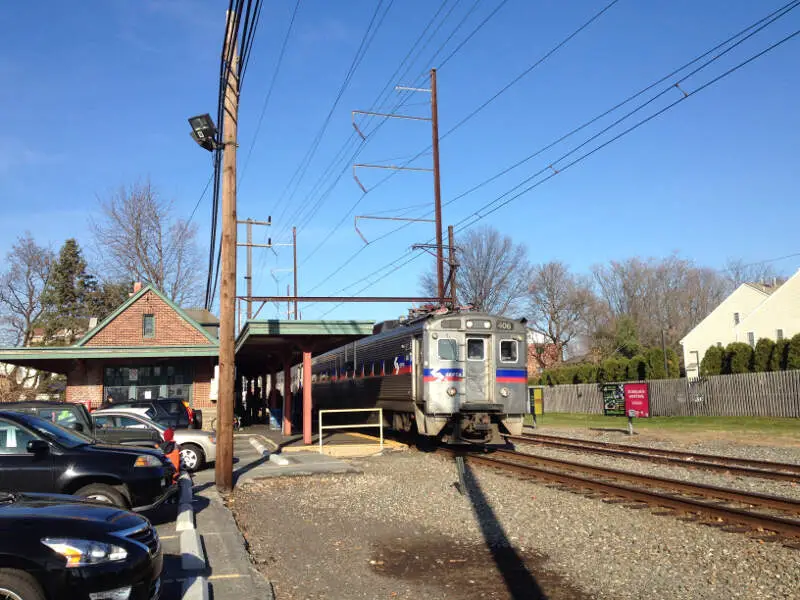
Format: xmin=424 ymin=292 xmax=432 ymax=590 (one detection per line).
xmin=304 ymin=312 xmax=529 ymax=443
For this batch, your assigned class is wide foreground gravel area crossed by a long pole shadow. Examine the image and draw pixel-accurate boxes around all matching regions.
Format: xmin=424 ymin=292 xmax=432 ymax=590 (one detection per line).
xmin=231 ymin=451 xmax=800 ymax=600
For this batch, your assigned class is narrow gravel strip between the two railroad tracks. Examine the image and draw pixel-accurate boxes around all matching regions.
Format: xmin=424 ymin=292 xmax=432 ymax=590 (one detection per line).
xmin=516 ymin=443 xmax=800 ymax=500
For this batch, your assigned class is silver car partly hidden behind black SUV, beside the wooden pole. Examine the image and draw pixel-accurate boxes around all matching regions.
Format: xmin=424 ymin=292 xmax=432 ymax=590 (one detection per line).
xmin=92 ymin=407 xmax=217 ymax=472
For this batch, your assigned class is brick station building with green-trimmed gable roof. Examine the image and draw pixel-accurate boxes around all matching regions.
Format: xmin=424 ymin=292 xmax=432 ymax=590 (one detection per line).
xmin=0 ymin=284 xmax=219 ymax=417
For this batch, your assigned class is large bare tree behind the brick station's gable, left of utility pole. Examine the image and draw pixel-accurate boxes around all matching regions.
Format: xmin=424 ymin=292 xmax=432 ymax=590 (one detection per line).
xmin=92 ymin=182 xmax=201 ymax=304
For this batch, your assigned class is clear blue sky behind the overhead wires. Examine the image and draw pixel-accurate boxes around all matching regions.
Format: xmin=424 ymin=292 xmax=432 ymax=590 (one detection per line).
xmin=0 ymin=0 xmax=800 ymax=319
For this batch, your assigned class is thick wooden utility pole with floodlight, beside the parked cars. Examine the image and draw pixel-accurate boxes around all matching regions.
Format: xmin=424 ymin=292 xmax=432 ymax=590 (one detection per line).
xmin=215 ymin=15 xmax=239 ymax=492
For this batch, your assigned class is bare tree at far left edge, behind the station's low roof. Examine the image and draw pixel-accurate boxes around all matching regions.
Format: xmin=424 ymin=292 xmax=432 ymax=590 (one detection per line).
xmin=0 ymin=233 xmax=54 ymax=401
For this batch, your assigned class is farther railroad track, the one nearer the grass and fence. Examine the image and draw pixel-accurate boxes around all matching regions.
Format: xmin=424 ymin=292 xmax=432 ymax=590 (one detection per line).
xmin=505 ymin=434 xmax=800 ymax=482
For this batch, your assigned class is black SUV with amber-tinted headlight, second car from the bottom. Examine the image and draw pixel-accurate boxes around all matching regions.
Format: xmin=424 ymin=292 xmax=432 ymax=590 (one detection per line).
xmin=0 ymin=411 xmax=177 ymax=510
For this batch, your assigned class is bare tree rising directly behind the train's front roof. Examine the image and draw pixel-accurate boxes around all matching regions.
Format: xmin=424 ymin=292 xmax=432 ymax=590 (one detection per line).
xmin=421 ymin=226 xmax=530 ymax=315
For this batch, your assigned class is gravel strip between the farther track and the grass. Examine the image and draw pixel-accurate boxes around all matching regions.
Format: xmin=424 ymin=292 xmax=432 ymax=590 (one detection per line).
xmin=523 ymin=424 xmax=800 ymax=465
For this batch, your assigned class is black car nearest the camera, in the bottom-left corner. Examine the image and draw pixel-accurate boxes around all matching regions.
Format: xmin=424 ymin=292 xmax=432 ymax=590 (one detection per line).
xmin=0 ymin=493 xmax=163 ymax=600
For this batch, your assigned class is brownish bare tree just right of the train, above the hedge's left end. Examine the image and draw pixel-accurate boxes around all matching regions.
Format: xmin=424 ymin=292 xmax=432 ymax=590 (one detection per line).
xmin=528 ymin=261 xmax=594 ymax=356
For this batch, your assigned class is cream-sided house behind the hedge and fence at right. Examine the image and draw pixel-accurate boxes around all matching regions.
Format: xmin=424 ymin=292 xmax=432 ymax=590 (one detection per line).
xmin=681 ymin=271 xmax=800 ymax=377
